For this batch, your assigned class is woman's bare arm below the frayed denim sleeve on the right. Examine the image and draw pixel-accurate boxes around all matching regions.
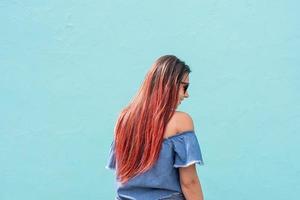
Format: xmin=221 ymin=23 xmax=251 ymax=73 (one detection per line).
xmin=179 ymin=164 xmax=204 ymax=200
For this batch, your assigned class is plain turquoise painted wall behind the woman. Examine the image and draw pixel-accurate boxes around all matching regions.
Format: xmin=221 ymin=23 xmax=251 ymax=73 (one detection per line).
xmin=0 ymin=0 xmax=300 ymax=200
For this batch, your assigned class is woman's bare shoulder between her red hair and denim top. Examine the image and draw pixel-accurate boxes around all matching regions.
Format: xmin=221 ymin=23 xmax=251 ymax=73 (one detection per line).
xmin=165 ymin=111 xmax=194 ymax=138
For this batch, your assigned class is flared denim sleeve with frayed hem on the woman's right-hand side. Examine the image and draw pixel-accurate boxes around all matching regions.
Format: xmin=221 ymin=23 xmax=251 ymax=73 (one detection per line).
xmin=172 ymin=131 xmax=204 ymax=168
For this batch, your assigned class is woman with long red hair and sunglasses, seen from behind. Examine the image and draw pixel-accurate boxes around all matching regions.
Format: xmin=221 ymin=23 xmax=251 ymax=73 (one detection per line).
xmin=106 ymin=55 xmax=203 ymax=200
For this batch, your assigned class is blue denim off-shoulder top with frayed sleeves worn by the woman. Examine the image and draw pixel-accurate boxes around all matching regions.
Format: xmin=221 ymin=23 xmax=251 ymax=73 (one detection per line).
xmin=106 ymin=130 xmax=204 ymax=200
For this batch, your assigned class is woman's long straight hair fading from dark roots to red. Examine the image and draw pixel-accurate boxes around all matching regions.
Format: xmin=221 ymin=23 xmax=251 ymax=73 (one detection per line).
xmin=114 ymin=55 xmax=191 ymax=183
